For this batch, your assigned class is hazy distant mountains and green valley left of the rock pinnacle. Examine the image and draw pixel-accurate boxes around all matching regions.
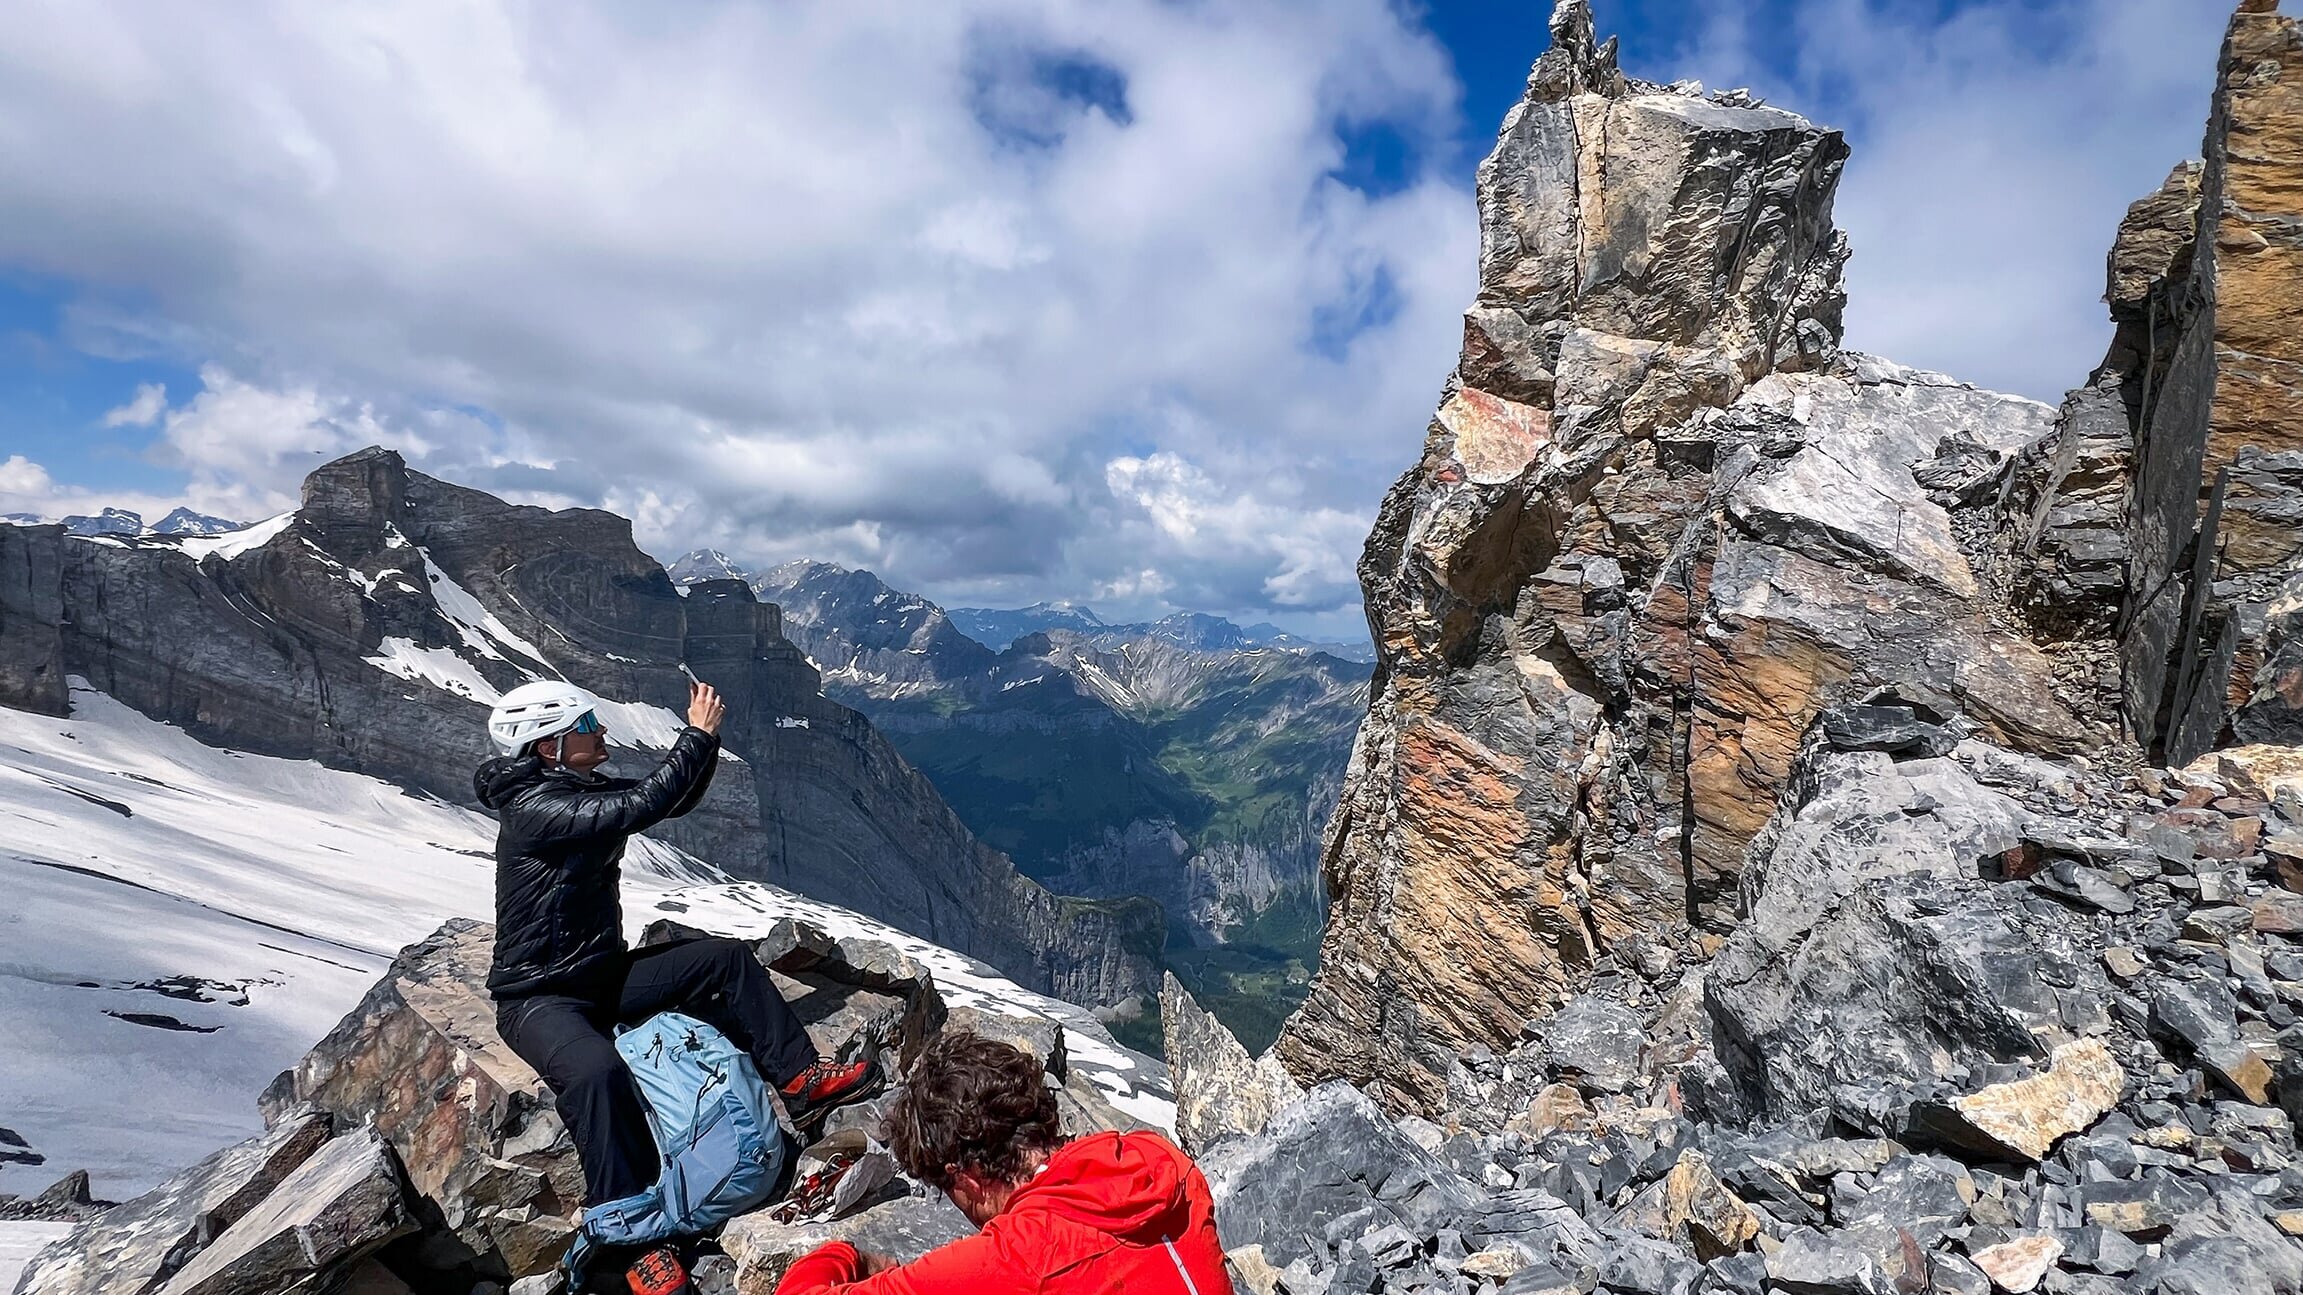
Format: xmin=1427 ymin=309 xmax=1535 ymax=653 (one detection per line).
xmin=670 ymin=551 xmax=1373 ymax=1046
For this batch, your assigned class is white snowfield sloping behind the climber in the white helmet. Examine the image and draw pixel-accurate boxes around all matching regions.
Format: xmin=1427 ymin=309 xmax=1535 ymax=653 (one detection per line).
xmin=0 ymin=680 xmax=1175 ymax=1201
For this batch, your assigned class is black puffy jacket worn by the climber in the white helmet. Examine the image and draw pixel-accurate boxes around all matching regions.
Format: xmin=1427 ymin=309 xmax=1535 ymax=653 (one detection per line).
xmin=472 ymin=728 xmax=719 ymax=998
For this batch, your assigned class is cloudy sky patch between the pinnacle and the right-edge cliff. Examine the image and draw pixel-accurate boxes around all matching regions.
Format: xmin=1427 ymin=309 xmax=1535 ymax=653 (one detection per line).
xmin=1670 ymin=0 xmax=2232 ymax=401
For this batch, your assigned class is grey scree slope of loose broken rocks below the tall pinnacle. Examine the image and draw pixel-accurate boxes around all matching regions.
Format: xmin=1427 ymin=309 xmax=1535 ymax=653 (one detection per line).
xmin=1179 ymin=714 xmax=2303 ymax=1295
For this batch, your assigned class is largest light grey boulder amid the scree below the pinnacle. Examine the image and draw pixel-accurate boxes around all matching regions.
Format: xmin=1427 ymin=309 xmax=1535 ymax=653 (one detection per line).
xmin=1704 ymin=742 xmax=2110 ymax=1131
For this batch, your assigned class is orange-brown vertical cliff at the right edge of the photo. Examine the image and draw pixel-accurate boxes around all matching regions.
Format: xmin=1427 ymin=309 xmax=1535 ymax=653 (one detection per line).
xmin=2098 ymin=0 xmax=2303 ymax=760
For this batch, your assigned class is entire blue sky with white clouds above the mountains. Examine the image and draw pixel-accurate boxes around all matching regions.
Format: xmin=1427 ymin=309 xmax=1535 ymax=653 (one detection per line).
xmin=0 ymin=0 xmax=2227 ymax=631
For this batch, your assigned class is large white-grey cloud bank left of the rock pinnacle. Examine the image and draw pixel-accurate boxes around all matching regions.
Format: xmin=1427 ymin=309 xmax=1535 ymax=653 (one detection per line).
xmin=0 ymin=0 xmax=1476 ymax=626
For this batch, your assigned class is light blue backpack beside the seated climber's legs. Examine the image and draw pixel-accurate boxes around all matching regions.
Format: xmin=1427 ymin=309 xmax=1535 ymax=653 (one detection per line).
xmin=567 ymin=1012 xmax=792 ymax=1290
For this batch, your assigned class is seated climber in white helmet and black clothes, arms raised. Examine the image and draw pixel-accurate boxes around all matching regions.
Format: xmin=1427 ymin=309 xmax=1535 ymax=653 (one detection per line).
xmin=472 ymin=682 xmax=880 ymax=1281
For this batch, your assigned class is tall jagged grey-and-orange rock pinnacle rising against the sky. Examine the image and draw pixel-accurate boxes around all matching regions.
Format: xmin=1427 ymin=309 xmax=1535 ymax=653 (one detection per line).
xmin=1280 ymin=0 xmax=2114 ymax=1111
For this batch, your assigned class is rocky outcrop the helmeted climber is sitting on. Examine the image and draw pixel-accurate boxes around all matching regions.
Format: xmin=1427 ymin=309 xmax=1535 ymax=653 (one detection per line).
xmin=16 ymin=919 xmax=1160 ymax=1295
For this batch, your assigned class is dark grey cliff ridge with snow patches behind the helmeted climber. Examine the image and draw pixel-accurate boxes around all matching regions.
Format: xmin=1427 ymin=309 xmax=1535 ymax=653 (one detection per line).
xmin=0 ymin=449 xmax=1161 ymax=1005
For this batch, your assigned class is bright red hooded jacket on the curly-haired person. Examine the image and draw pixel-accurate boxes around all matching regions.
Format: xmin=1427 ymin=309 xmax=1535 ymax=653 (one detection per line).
xmin=776 ymin=1134 xmax=1232 ymax=1295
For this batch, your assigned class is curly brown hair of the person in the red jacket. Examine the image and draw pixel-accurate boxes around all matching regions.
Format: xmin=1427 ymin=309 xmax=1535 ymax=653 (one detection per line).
xmin=887 ymin=1032 xmax=1064 ymax=1187
